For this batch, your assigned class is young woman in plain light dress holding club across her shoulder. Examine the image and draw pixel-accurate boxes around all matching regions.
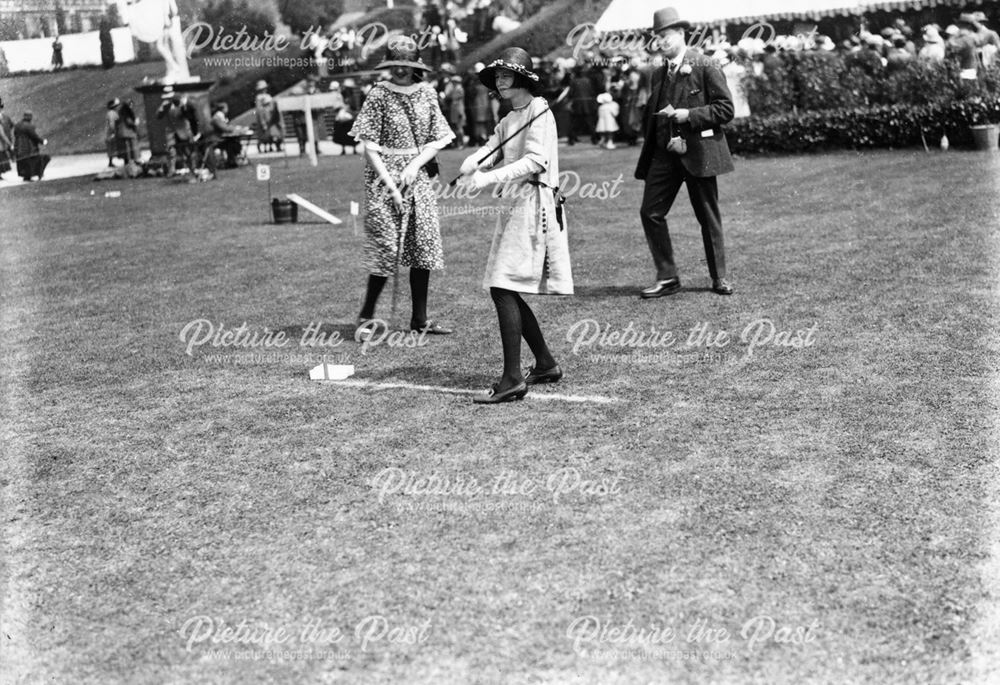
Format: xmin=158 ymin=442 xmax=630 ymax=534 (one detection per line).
xmin=461 ymin=48 xmax=573 ymax=404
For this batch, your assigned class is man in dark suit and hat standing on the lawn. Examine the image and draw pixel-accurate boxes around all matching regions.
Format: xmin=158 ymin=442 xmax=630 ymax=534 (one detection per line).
xmin=635 ymin=7 xmax=733 ymax=298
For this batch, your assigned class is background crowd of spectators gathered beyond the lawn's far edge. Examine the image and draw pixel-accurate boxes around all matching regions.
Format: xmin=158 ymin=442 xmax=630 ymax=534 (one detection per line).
xmin=52 ymin=6 xmax=1000 ymax=173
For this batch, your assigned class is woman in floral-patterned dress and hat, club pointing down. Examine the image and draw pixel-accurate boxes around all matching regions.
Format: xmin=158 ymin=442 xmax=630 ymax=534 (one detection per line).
xmin=350 ymin=36 xmax=455 ymax=336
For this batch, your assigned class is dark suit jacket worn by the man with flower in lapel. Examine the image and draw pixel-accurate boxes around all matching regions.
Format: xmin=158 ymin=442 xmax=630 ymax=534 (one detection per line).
xmin=635 ymin=48 xmax=733 ymax=179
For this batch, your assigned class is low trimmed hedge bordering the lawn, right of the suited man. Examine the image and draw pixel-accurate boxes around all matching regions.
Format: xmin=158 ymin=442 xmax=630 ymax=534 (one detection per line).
xmin=726 ymin=97 xmax=1000 ymax=153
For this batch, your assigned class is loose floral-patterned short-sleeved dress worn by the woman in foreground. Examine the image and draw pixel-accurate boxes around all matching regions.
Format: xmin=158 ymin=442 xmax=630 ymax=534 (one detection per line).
xmin=349 ymin=81 xmax=455 ymax=276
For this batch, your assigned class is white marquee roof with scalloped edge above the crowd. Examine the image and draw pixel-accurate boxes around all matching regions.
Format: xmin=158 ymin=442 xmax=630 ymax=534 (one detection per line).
xmin=595 ymin=0 xmax=982 ymax=32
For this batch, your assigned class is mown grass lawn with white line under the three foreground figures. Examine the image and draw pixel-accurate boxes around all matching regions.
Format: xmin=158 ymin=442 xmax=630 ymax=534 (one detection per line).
xmin=0 ymin=149 xmax=1000 ymax=683
